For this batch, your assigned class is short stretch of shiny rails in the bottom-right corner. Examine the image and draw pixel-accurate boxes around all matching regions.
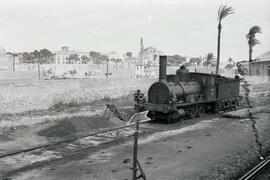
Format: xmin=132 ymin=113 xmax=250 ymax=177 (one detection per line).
xmin=239 ymin=156 xmax=270 ymax=180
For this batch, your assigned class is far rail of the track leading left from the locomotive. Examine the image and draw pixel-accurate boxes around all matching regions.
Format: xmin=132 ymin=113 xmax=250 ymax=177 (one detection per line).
xmin=0 ymin=124 xmax=133 ymax=159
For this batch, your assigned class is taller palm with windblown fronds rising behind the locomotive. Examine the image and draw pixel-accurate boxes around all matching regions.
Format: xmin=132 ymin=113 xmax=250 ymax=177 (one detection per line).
xmin=216 ymin=5 xmax=234 ymax=74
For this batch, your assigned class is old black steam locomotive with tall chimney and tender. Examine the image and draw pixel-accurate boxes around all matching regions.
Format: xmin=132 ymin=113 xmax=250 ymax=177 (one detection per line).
xmin=134 ymin=56 xmax=241 ymax=123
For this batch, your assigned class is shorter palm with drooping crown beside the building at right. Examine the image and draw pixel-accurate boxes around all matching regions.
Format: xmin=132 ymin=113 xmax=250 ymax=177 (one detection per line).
xmin=246 ymin=26 xmax=262 ymax=75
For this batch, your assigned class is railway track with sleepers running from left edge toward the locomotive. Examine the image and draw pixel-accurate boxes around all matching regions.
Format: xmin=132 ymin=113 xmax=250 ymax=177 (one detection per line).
xmin=0 ymin=120 xmax=162 ymax=177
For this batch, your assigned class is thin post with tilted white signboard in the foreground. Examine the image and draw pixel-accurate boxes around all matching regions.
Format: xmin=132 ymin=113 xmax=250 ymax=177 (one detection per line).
xmin=127 ymin=111 xmax=151 ymax=180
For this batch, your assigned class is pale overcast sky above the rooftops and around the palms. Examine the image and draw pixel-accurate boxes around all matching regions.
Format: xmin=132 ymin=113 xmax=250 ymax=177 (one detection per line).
xmin=0 ymin=0 xmax=270 ymax=61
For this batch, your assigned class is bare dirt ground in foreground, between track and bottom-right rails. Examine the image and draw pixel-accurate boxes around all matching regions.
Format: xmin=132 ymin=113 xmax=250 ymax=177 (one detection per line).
xmin=2 ymin=114 xmax=270 ymax=180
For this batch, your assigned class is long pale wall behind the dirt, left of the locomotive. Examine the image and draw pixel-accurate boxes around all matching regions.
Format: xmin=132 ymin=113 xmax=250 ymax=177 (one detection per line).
xmin=0 ymin=79 xmax=155 ymax=113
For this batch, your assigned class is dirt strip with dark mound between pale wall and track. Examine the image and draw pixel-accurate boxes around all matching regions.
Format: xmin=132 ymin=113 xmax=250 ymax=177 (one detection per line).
xmin=0 ymin=95 xmax=134 ymax=153
